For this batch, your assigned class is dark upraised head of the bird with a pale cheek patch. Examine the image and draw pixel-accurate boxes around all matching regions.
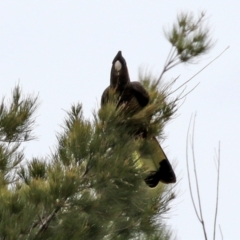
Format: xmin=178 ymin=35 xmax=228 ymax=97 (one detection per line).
xmin=110 ymin=51 xmax=130 ymax=90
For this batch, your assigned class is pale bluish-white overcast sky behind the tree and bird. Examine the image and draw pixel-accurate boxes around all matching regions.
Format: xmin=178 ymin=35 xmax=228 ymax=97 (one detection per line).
xmin=0 ymin=0 xmax=240 ymax=240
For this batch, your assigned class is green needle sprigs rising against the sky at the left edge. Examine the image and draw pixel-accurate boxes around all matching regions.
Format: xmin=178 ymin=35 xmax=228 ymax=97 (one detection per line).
xmin=0 ymin=86 xmax=38 ymax=184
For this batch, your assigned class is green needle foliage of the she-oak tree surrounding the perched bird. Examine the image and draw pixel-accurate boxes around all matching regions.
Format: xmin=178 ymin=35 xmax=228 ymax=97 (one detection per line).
xmin=0 ymin=11 xmax=210 ymax=240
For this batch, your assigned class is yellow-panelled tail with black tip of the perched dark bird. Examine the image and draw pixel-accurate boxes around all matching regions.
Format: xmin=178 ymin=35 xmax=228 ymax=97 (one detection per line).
xmin=141 ymin=137 xmax=176 ymax=188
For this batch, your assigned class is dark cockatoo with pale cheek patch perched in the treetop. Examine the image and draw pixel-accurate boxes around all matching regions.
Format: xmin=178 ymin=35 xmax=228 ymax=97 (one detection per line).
xmin=101 ymin=51 xmax=176 ymax=188
